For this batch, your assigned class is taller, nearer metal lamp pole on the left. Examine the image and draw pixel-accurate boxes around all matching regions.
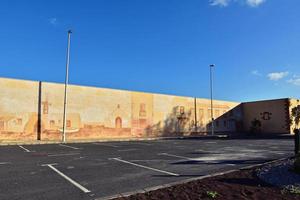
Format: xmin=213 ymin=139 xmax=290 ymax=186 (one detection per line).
xmin=62 ymin=30 xmax=72 ymax=143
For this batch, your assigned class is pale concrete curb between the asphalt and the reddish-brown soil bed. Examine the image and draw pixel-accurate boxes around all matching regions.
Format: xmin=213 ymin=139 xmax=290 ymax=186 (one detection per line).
xmin=95 ymin=157 xmax=293 ymax=200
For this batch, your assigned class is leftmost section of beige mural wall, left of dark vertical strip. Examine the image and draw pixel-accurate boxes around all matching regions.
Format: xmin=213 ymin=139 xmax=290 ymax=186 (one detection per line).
xmin=0 ymin=79 xmax=39 ymax=140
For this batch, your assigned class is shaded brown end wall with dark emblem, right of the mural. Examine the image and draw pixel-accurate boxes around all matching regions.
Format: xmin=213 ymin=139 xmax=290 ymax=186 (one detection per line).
xmin=242 ymin=99 xmax=290 ymax=133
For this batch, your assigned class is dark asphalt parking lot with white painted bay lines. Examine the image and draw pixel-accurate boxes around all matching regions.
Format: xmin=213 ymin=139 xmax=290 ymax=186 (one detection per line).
xmin=0 ymin=139 xmax=294 ymax=200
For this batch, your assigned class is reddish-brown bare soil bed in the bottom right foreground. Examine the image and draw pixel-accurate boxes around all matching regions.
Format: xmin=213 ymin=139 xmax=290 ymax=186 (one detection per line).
xmin=115 ymin=169 xmax=300 ymax=200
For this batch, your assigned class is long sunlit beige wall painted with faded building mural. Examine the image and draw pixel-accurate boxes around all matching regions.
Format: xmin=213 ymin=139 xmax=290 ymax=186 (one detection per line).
xmin=0 ymin=78 xmax=241 ymax=141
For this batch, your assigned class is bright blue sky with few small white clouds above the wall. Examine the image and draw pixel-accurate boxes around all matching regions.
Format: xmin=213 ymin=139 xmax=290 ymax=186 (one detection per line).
xmin=0 ymin=0 xmax=300 ymax=101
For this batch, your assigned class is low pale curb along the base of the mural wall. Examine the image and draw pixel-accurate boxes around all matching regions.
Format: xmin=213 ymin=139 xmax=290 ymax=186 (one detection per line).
xmin=0 ymin=135 xmax=228 ymax=146
